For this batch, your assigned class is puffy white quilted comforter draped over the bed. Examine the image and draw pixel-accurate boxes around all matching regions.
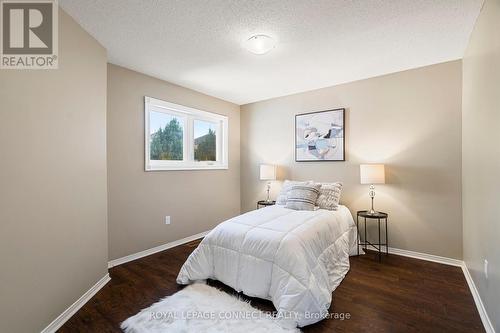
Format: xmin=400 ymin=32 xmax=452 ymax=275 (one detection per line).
xmin=177 ymin=206 xmax=357 ymax=326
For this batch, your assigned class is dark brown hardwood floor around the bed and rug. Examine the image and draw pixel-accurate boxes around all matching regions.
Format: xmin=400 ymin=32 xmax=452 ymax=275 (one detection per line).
xmin=58 ymin=241 xmax=484 ymax=333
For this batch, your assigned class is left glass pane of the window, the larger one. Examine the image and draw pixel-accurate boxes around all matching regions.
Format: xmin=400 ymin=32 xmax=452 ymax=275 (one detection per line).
xmin=149 ymin=111 xmax=184 ymax=161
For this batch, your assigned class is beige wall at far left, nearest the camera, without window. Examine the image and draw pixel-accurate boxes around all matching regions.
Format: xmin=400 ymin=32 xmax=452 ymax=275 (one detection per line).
xmin=0 ymin=10 xmax=108 ymax=333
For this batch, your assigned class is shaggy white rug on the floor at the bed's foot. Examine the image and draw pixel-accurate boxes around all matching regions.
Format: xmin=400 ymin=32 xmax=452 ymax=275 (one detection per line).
xmin=121 ymin=283 xmax=300 ymax=333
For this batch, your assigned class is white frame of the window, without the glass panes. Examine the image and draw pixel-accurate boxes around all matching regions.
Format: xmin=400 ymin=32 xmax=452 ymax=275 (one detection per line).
xmin=144 ymin=96 xmax=229 ymax=171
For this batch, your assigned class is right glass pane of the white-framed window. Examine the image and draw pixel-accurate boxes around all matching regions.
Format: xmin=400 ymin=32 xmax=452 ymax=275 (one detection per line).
xmin=193 ymin=120 xmax=217 ymax=161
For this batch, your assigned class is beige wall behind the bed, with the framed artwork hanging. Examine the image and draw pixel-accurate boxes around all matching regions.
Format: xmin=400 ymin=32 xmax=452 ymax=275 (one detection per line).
xmin=241 ymin=61 xmax=462 ymax=258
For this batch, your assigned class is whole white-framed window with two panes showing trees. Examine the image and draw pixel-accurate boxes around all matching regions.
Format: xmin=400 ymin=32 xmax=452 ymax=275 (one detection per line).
xmin=144 ymin=96 xmax=228 ymax=171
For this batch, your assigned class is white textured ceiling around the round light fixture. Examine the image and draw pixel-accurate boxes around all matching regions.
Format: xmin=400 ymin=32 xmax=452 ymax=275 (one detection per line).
xmin=59 ymin=0 xmax=483 ymax=104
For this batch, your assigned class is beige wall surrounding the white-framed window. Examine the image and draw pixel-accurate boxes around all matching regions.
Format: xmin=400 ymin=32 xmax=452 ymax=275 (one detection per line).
xmin=107 ymin=65 xmax=240 ymax=259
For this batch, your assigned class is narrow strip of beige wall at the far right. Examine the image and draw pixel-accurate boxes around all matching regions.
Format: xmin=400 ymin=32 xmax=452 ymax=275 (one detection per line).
xmin=462 ymin=0 xmax=500 ymax=332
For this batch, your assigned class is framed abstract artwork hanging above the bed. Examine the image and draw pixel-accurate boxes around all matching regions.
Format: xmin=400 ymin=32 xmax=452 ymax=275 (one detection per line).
xmin=295 ymin=109 xmax=345 ymax=162
